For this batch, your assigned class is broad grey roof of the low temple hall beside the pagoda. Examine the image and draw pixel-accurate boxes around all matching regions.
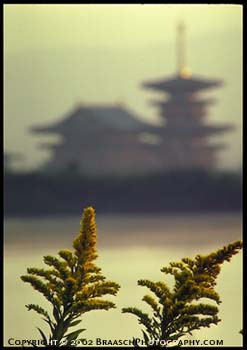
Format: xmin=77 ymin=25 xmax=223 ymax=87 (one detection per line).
xmin=31 ymin=105 xmax=153 ymax=134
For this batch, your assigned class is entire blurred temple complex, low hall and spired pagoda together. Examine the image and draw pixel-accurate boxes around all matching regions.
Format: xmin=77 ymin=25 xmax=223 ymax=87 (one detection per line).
xmin=31 ymin=25 xmax=232 ymax=176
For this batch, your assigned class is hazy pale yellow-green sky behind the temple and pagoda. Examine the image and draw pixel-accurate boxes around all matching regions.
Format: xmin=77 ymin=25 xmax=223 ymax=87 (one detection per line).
xmin=4 ymin=4 xmax=242 ymax=168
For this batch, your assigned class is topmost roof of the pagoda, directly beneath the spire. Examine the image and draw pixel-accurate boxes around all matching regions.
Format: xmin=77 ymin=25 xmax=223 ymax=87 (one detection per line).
xmin=142 ymin=74 xmax=223 ymax=94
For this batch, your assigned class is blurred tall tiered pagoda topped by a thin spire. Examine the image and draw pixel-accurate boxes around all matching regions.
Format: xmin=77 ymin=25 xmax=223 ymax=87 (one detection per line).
xmin=142 ymin=24 xmax=232 ymax=170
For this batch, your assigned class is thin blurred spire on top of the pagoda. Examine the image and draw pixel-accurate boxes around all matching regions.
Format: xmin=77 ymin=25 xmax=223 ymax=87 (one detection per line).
xmin=177 ymin=22 xmax=190 ymax=78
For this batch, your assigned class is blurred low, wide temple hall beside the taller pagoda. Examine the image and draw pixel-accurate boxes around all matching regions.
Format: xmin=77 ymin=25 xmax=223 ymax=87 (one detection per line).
xmin=32 ymin=105 xmax=161 ymax=176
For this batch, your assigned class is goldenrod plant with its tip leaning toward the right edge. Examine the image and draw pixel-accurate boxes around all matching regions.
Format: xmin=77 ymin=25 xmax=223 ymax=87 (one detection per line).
xmin=122 ymin=241 xmax=242 ymax=347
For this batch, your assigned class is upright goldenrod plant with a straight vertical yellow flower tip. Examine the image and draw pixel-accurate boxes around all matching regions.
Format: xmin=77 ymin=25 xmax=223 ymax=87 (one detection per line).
xmin=21 ymin=207 xmax=120 ymax=346
